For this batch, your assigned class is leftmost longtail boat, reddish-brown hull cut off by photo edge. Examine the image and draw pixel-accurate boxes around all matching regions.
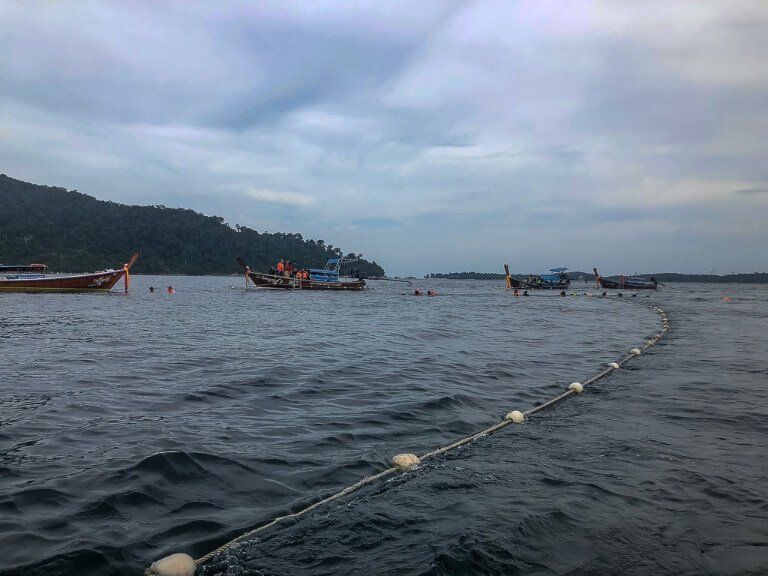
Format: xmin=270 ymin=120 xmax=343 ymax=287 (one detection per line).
xmin=0 ymin=254 xmax=139 ymax=293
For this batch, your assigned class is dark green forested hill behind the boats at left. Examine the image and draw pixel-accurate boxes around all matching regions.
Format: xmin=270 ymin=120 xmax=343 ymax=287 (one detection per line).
xmin=0 ymin=174 xmax=384 ymax=276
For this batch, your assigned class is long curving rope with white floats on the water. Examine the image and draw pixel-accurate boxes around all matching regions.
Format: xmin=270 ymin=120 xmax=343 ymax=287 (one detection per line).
xmin=144 ymin=294 xmax=670 ymax=576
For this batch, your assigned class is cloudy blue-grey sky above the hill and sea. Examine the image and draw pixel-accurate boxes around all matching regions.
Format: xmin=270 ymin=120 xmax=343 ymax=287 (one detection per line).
xmin=0 ymin=0 xmax=768 ymax=275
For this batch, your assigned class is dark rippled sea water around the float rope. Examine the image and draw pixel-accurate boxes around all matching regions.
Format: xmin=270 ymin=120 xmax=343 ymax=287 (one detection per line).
xmin=0 ymin=276 xmax=768 ymax=576
